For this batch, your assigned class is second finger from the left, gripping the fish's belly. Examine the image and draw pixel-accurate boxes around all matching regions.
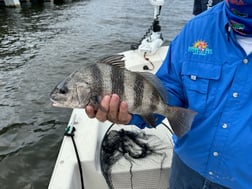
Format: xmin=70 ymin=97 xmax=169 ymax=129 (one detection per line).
xmin=95 ymin=95 xmax=110 ymax=121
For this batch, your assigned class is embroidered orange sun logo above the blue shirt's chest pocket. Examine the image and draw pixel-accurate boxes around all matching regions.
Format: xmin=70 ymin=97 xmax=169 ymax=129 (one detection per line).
xmin=188 ymin=40 xmax=213 ymax=55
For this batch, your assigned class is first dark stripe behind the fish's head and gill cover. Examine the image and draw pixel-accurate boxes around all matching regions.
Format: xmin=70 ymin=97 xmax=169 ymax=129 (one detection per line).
xmin=90 ymin=64 xmax=103 ymax=96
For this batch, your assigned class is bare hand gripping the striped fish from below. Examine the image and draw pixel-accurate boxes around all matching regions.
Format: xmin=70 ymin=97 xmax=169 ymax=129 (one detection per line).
xmin=85 ymin=94 xmax=132 ymax=124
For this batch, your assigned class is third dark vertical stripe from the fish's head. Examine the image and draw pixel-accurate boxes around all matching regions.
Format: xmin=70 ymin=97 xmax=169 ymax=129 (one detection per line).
xmin=134 ymin=75 xmax=144 ymax=108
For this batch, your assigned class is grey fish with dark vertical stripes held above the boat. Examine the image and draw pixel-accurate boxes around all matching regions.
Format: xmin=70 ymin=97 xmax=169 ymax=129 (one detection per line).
xmin=50 ymin=54 xmax=197 ymax=137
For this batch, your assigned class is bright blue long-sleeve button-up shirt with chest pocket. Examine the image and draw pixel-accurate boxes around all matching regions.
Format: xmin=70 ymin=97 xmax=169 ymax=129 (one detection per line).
xmin=131 ymin=3 xmax=252 ymax=189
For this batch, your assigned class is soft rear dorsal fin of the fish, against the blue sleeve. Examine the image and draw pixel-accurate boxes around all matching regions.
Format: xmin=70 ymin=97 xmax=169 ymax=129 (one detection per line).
xmin=137 ymin=72 xmax=168 ymax=103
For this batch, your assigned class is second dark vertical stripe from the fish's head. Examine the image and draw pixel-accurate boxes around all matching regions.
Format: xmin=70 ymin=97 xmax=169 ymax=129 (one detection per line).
xmin=110 ymin=66 xmax=124 ymax=98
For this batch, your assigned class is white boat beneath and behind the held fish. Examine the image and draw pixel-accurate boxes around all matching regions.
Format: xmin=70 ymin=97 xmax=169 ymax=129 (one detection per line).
xmin=48 ymin=0 xmax=173 ymax=189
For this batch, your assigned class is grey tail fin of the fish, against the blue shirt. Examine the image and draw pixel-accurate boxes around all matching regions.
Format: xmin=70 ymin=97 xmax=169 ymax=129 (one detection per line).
xmin=166 ymin=106 xmax=197 ymax=137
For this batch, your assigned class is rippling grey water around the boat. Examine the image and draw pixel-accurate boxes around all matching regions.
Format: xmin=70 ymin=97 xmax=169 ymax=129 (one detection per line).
xmin=0 ymin=0 xmax=193 ymax=189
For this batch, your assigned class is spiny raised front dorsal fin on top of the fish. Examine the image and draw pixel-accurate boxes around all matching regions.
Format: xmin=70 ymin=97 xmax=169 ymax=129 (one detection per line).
xmin=97 ymin=54 xmax=125 ymax=68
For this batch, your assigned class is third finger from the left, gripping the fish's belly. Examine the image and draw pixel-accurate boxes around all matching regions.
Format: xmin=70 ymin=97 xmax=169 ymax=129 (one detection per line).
xmin=108 ymin=94 xmax=120 ymax=122
